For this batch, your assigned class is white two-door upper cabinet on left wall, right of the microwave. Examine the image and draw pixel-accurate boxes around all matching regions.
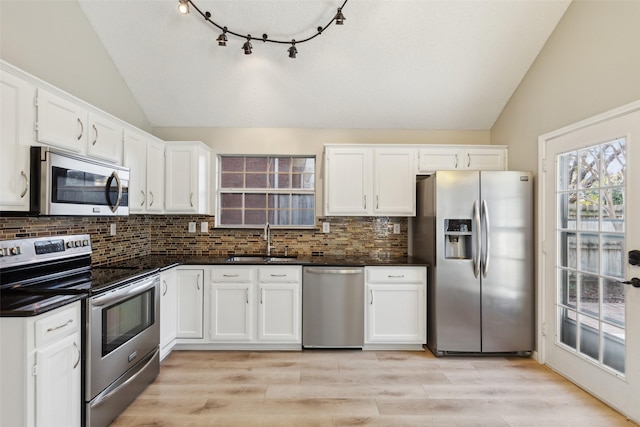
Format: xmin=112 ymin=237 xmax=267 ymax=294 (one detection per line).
xmin=124 ymin=129 xmax=165 ymax=213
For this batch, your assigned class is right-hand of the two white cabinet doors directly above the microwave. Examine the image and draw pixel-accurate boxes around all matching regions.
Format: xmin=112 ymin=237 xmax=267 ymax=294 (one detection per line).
xmin=87 ymin=113 xmax=124 ymax=165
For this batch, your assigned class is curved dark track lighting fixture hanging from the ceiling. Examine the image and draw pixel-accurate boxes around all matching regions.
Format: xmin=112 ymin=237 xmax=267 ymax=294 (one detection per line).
xmin=178 ymin=0 xmax=349 ymax=58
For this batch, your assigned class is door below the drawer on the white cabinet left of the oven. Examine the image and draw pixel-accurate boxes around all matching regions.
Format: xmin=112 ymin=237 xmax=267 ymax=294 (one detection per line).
xmin=35 ymin=331 xmax=82 ymax=427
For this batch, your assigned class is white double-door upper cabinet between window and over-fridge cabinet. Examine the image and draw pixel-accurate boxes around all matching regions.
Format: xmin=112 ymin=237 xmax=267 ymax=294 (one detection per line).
xmin=324 ymin=145 xmax=415 ymax=216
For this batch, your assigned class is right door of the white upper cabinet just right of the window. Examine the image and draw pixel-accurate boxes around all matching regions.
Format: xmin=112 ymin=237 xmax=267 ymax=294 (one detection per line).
xmin=373 ymin=148 xmax=416 ymax=216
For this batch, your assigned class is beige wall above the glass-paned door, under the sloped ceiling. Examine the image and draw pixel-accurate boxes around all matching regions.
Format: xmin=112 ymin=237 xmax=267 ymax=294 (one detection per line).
xmin=491 ymin=0 xmax=640 ymax=172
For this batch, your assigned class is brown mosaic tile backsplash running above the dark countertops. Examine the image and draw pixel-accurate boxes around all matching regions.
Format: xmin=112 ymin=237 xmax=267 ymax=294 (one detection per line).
xmin=0 ymin=215 xmax=407 ymax=265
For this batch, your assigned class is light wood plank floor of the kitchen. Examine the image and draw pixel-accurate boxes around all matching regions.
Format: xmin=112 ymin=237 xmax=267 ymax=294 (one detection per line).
xmin=112 ymin=350 xmax=636 ymax=427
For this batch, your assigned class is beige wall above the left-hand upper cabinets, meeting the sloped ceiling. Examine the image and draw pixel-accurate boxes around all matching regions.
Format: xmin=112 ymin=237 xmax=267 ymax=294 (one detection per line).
xmin=0 ymin=0 xmax=151 ymax=131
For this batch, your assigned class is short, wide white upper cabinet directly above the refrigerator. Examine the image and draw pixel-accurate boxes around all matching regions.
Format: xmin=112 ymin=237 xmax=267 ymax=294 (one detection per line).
xmin=418 ymin=145 xmax=507 ymax=173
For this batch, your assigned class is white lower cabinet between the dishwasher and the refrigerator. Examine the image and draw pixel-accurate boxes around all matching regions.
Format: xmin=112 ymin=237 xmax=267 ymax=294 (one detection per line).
xmin=364 ymin=267 xmax=427 ymax=349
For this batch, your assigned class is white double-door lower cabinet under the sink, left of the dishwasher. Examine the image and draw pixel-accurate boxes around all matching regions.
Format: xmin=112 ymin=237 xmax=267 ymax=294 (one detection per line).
xmin=209 ymin=265 xmax=302 ymax=349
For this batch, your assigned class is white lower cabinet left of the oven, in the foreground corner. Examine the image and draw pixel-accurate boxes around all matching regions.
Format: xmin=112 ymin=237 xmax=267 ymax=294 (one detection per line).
xmin=0 ymin=302 xmax=82 ymax=427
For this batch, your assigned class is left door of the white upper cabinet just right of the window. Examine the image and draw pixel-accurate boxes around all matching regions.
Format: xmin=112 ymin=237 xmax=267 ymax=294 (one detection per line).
xmin=324 ymin=148 xmax=373 ymax=216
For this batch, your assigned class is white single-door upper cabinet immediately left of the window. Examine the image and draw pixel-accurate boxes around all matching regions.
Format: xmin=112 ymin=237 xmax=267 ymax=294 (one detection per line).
xmin=165 ymin=141 xmax=211 ymax=214
